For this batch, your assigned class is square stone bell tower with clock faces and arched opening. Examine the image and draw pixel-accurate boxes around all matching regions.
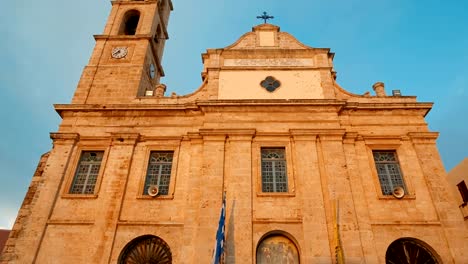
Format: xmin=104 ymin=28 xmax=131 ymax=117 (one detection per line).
xmin=72 ymin=0 xmax=173 ymax=104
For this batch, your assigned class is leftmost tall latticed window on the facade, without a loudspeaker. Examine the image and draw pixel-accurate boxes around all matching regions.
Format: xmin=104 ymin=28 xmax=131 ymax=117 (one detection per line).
xmin=70 ymin=151 xmax=104 ymax=194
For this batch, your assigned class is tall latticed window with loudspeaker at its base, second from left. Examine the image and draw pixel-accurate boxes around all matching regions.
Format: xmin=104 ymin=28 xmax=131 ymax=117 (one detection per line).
xmin=143 ymin=151 xmax=174 ymax=195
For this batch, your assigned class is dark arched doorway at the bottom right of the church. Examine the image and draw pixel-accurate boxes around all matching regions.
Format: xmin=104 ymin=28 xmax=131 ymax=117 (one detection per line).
xmin=385 ymin=238 xmax=441 ymax=264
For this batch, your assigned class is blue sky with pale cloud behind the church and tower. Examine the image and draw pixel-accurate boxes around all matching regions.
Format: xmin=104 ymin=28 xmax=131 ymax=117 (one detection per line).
xmin=0 ymin=0 xmax=468 ymax=229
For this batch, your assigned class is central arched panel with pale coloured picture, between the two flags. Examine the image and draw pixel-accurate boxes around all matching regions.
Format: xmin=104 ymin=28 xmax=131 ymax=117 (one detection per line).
xmin=256 ymin=234 xmax=300 ymax=264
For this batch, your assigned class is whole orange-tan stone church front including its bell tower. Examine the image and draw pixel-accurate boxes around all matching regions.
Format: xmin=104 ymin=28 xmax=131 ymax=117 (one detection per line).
xmin=0 ymin=0 xmax=468 ymax=264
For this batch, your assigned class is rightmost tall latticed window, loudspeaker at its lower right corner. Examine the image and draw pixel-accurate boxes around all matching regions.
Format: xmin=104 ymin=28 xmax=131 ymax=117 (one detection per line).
xmin=373 ymin=150 xmax=407 ymax=195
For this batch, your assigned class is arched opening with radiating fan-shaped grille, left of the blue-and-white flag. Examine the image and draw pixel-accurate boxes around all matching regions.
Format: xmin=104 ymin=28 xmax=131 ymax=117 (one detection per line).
xmin=118 ymin=235 xmax=172 ymax=264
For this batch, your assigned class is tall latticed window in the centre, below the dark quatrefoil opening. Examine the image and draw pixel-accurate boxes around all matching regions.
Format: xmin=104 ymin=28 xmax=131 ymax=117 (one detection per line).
xmin=261 ymin=148 xmax=288 ymax=192
